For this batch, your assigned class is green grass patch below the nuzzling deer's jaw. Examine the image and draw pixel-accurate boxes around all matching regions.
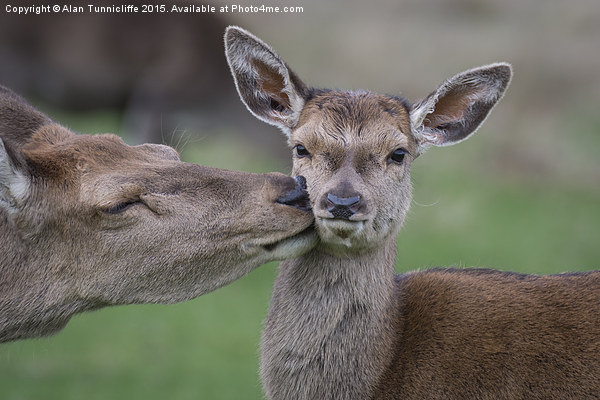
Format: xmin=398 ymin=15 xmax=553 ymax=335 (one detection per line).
xmin=0 ymin=264 xmax=275 ymax=400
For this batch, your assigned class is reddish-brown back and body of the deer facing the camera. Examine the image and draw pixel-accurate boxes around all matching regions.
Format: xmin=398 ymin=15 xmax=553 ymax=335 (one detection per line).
xmin=372 ymin=269 xmax=600 ymax=399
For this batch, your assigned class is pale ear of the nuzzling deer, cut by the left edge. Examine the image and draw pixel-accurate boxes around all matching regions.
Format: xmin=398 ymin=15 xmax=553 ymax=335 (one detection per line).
xmin=0 ymin=138 xmax=29 ymax=213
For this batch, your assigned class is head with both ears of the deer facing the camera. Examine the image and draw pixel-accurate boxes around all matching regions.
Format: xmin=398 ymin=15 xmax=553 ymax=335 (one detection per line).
xmin=225 ymin=27 xmax=512 ymax=253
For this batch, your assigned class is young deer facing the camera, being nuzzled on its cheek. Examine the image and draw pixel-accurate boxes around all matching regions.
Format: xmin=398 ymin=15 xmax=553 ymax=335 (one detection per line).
xmin=225 ymin=26 xmax=600 ymax=400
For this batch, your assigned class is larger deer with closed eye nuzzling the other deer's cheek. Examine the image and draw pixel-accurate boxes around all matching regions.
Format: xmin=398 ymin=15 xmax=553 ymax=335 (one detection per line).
xmin=0 ymin=87 xmax=315 ymax=342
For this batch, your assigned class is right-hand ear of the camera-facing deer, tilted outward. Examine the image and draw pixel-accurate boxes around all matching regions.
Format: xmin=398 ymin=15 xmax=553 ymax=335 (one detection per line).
xmin=410 ymin=63 xmax=512 ymax=154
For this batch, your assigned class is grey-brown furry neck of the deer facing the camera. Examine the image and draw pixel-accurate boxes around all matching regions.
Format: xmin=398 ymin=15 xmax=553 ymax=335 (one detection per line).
xmin=261 ymin=240 xmax=397 ymax=399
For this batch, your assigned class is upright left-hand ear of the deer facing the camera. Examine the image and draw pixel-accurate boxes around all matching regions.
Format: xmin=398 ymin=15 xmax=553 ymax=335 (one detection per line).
xmin=225 ymin=26 xmax=308 ymax=136
